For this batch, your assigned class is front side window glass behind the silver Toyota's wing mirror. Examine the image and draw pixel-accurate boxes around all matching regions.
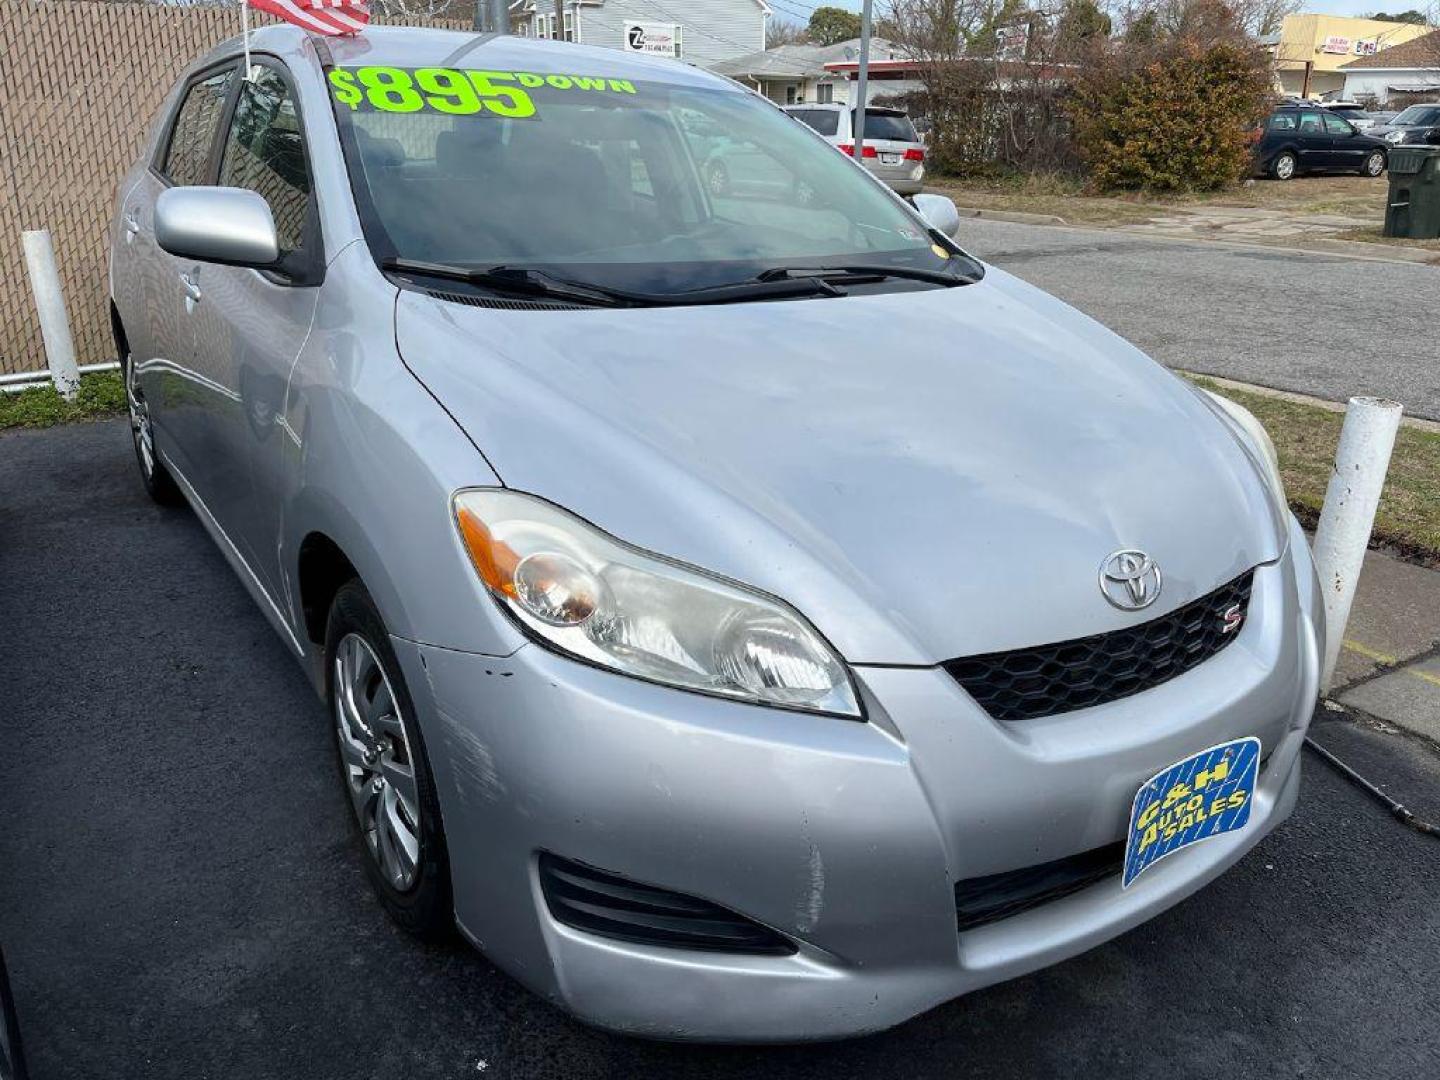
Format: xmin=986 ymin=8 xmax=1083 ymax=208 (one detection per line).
xmin=220 ymin=68 xmax=310 ymax=258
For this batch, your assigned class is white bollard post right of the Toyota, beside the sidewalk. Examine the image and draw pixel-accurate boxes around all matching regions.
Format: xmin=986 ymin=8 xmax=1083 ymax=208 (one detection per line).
xmin=1315 ymin=397 xmax=1403 ymax=690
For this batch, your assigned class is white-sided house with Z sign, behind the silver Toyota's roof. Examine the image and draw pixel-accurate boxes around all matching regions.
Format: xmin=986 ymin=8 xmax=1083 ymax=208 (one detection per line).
xmin=510 ymin=0 xmax=770 ymax=68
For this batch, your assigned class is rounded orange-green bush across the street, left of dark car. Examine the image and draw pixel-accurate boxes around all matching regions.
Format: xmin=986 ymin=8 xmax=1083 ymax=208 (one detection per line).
xmin=1070 ymin=42 xmax=1273 ymax=192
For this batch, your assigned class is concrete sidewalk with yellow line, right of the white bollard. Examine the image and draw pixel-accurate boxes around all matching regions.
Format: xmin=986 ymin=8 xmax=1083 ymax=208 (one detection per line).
xmin=1329 ymin=552 xmax=1440 ymax=747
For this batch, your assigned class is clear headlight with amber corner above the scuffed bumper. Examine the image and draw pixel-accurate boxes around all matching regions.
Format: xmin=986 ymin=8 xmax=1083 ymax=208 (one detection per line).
xmin=454 ymin=488 xmax=861 ymax=719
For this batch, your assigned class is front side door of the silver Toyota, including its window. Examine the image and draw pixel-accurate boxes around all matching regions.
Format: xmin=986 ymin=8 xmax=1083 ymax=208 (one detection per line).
xmin=203 ymin=56 xmax=324 ymax=598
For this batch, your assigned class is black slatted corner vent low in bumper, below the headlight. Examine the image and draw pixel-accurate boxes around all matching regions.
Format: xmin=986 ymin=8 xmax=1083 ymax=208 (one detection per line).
xmin=540 ymin=852 xmax=795 ymax=955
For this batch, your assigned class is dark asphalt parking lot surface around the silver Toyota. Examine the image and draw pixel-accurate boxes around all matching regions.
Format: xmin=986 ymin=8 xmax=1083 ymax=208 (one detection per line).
xmin=0 ymin=420 xmax=1440 ymax=1080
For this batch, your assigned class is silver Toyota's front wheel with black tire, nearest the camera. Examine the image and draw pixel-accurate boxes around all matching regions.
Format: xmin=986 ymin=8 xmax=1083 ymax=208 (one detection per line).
xmin=325 ymin=579 xmax=455 ymax=940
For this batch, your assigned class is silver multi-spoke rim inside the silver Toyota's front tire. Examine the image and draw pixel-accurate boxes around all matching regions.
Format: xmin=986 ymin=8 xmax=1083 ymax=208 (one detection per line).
xmin=334 ymin=634 xmax=420 ymax=893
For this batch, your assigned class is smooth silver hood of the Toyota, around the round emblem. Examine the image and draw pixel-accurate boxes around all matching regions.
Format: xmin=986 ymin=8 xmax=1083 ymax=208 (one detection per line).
xmin=396 ymin=268 xmax=1283 ymax=664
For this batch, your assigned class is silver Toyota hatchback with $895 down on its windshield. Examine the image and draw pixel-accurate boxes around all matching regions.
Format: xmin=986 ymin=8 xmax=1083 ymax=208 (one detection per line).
xmin=109 ymin=26 xmax=1322 ymax=1040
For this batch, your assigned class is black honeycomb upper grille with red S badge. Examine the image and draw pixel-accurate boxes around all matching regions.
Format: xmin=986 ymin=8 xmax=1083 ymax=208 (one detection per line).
xmin=945 ymin=570 xmax=1254 ymax=720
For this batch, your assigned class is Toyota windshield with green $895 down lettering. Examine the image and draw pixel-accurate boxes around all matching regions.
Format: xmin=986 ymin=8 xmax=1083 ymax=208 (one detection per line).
xmin=330 ymin=68 xmax=979 ymax=292
